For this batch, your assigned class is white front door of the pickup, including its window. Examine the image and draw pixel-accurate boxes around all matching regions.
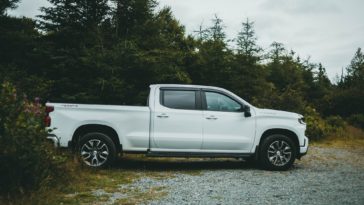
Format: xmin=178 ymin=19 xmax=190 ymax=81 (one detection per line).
xmin=202 ymin=91 xmax=255 ymax=153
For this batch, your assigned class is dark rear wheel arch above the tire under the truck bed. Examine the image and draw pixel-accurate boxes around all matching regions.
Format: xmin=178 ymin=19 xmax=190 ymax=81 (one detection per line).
xmin=71 ymin=124 xmax=122 ymax=152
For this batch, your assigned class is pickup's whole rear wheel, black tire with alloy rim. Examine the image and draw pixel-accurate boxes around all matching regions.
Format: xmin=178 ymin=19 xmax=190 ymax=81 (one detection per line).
xmin=78 ymin=132 xmax=116 ymax=168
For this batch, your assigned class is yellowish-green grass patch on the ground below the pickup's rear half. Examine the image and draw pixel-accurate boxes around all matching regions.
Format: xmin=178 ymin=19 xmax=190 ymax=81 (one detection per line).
xmin=15 ymin=155 xmax=200 ymax=205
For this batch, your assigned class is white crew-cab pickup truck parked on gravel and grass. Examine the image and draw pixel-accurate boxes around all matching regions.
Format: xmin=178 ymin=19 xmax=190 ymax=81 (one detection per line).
xmin=45 ymin=84 xmax=308 ymax=170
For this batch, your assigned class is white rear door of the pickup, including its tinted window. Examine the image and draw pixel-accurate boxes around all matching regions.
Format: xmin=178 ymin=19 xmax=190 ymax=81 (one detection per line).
xmin=150 ymin=87 xmax=203 ymax=152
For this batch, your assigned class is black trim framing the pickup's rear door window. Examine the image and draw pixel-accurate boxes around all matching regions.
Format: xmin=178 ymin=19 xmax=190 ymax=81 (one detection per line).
xmin=159 ymin=87 xmax=202 ymax=111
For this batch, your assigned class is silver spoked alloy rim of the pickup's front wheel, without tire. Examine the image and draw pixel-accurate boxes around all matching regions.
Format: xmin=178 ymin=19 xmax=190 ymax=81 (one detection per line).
xmin=268 ymin=140 xmax=292 ymax=166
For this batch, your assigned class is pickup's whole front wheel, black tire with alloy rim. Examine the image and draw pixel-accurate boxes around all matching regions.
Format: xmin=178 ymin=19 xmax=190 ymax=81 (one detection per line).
xmin=259 ymin=134 xmax=297 ymax=171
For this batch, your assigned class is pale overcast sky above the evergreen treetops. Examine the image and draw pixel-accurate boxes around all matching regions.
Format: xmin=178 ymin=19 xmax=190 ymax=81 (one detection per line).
xmin=9 ymin=0 xmax=364 ymax=80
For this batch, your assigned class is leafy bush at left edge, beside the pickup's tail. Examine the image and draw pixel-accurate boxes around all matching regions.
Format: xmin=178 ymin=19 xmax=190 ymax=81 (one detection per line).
xmin=0 ymin=82 xmax=65 ymax=196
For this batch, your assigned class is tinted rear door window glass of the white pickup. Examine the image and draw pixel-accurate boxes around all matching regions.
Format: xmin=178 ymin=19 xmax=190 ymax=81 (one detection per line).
xmin=161 ymin=90 xmax=196 ymax=110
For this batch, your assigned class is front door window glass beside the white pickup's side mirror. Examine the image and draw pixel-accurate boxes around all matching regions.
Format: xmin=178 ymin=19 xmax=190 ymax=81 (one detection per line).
xmin=205 ymin=92 xmax=241 ymax=112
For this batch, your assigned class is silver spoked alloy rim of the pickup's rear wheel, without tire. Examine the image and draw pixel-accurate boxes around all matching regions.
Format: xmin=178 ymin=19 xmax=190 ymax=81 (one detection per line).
xmin=80 ymin=139 xmax=109 ymax=167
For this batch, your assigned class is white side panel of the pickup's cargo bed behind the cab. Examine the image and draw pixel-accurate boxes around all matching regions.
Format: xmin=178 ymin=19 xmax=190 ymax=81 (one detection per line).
xmin=47 ymin=103 xmax=150 ymax=151
